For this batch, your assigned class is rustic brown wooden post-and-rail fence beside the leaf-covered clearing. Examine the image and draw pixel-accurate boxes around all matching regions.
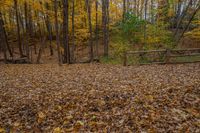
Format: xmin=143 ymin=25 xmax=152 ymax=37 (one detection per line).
xmin=123 ymin=48 xmax=200 ymax=66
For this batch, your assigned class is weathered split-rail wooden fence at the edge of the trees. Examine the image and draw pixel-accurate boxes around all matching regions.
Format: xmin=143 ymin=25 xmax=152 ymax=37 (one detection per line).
xmin=123 ymin=48 xmax=200 ymax=66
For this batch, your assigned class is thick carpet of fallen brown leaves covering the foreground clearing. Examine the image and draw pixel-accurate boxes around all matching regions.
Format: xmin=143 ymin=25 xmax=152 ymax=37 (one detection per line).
xmin=0 ymin=63 xmax=200 ymax=133
